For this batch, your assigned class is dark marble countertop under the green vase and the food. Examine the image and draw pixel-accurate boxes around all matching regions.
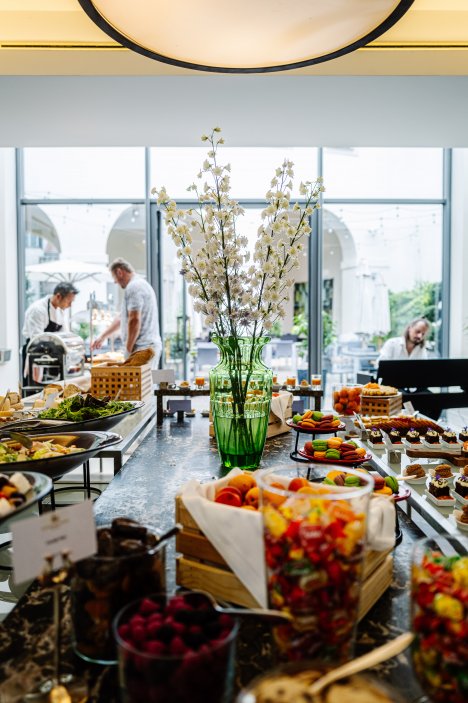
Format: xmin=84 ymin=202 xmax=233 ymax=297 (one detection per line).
xmin=0 ymin=416 xmax=428 ymax=703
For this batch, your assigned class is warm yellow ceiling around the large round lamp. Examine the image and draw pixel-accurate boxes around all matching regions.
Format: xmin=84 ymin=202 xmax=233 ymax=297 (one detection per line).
xmin=0 ymin=0 xmax=468 ymax=76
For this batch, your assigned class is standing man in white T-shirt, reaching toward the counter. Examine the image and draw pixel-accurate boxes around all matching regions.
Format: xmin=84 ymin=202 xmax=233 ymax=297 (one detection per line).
xmin=93 ymin=259 xmax=162 ymax=368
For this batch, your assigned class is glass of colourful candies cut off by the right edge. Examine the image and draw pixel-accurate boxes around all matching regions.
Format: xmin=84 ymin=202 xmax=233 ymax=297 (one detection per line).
xmin=411 ymin=534 xmax=468 ymax=703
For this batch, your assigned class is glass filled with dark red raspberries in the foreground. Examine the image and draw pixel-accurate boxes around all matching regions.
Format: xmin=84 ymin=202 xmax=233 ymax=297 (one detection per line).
xmin=114 ymin=592 xmax=238 ymax=703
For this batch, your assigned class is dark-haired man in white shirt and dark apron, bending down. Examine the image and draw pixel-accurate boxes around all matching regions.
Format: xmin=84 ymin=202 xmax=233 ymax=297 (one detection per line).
xmin=22 ymin=282 xmax=78 ymax=377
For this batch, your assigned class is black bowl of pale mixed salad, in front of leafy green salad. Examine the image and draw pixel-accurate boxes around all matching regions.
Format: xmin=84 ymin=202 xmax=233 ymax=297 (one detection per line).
xmin=0 ymin=428 xmax=122 ymax=480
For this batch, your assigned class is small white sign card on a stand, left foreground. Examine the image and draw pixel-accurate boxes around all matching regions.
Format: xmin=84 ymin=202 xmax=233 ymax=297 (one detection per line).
xmin=11 ymin=500 xmax=97 ymax=584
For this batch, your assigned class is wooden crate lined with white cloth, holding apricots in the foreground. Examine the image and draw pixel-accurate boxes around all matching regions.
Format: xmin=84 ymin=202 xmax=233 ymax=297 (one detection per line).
xmin=176 ymin=496 xmax=393 ymax=619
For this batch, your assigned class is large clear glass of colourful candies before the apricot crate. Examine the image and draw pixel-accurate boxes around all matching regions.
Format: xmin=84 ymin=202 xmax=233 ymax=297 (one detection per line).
xmin=257 ymin=464 xmax=374 ymax=664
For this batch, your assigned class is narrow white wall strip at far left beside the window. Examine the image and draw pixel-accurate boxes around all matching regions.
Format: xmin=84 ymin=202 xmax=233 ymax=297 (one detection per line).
xmin=0 ymin=149 xmax=19 ymax=395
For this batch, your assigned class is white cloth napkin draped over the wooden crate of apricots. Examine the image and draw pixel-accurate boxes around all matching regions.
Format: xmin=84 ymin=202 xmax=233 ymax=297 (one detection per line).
xmin=181 ymin=469 xmax=395 ymax=608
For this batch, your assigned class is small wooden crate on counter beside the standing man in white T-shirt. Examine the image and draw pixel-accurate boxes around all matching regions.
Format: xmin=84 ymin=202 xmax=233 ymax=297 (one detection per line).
xmin=90 ymin=364 xmax=153 ymax=400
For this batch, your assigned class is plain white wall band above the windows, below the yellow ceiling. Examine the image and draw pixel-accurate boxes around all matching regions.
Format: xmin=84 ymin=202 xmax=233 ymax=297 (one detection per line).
xmin=0 ymin=74 xmax=468 ymax=147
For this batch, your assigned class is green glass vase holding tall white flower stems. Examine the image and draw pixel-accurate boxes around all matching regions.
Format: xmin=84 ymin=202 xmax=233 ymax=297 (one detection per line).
xmin=210 ymin=337 xmax=272 ymax=470
